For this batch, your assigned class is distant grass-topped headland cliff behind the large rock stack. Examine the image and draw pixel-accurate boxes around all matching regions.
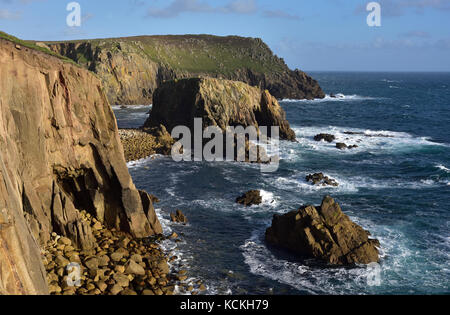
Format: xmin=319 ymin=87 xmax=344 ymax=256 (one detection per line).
xmin=41 ymin=35 xmax=325 ymax=105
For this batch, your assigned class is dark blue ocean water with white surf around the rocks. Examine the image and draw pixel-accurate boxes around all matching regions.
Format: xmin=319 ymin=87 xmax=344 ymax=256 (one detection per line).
xmin=115 ymin=73 xmax=450 ymax=294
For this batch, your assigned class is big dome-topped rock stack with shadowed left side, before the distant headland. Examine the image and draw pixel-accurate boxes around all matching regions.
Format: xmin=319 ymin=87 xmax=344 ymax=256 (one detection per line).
xmin=145 ymin=78 xmax=295 ymax=140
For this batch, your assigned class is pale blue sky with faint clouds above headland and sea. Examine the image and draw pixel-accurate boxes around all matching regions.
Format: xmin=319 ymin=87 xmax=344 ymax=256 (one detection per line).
xmin=0 ymin=0 xmax=450 ymax=71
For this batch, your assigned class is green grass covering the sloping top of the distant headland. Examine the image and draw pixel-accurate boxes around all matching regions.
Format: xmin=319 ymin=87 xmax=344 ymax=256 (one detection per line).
xmin=44 ymin=35 xmax=288 ymax=75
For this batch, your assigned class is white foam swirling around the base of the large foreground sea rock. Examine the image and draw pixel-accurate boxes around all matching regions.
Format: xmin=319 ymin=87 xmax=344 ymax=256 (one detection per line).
xmin=240 ymin=217 xmax=428 ymax=294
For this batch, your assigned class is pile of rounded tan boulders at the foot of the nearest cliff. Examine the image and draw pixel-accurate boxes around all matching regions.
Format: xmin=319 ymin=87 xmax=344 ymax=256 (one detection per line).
xmin=43 ymin=211 xmax=205 ymax=295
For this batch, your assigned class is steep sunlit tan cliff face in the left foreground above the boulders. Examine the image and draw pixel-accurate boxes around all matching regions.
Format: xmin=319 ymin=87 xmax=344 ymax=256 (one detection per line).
xmin=0 ymin=39 xmax=162 ymax=294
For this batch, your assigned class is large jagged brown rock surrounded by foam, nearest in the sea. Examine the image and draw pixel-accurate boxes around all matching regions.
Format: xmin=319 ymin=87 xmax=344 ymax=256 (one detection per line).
xmin=266 ymin=196 xmax=380 ymax=265
